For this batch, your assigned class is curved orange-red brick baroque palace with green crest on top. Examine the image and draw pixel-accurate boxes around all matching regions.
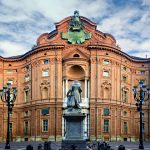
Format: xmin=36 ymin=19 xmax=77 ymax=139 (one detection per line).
xmin=0 ymin=11 xmax=150 ymax=142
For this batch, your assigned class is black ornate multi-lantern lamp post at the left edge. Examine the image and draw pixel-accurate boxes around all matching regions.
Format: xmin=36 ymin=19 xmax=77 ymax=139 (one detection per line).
xmin=0 ymin=83 xmax=17 ymax=149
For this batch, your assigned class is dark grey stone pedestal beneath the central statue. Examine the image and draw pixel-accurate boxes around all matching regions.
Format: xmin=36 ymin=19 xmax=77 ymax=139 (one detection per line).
xmin=61 ymin=111 xmax=87 ymax=150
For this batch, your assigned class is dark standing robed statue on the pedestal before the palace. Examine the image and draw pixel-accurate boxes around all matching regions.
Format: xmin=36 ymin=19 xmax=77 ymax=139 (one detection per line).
xmin=67 ymin=80 xmax=82 ymax=109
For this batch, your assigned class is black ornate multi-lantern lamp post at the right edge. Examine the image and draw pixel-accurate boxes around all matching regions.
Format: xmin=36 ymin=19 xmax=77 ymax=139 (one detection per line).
xmin=133 ymin=81 xmax=150 ymax=149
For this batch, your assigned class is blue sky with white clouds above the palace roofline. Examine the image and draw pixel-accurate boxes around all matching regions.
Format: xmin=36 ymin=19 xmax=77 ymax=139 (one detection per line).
xmin=0 ymin=0 xmax=150 ymax=58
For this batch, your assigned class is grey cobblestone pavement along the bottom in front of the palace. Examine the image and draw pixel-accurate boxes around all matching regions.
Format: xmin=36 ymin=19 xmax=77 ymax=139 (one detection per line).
xmin=0 ymin=142 xmax=150 ymax=150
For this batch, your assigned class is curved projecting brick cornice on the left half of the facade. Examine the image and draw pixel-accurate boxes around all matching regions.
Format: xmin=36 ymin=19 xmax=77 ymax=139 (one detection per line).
xmin=0 ymin=44 xmax=65 ymax=62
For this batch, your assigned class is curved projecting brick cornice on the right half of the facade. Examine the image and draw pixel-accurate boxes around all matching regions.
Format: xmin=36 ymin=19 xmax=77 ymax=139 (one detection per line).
xmin=87 ymin=44 xmax=150 ymax=63
